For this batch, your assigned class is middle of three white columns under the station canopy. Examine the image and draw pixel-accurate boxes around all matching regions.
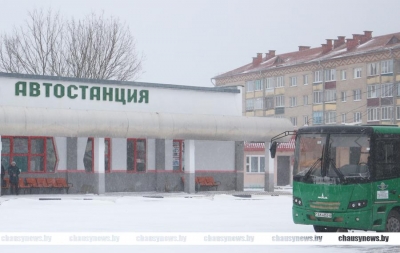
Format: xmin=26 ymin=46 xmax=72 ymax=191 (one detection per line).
xmin=184 ymin=140 xmax=196 ymax=193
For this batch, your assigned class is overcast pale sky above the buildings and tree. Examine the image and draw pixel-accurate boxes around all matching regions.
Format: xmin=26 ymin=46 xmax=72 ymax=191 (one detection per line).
xmin=0 ymin=0 xmax=400 ymax=87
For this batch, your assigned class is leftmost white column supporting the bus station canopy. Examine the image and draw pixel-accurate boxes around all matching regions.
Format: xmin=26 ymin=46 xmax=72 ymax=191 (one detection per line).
xmin=93 ymin=138 xmax=105 ymax=194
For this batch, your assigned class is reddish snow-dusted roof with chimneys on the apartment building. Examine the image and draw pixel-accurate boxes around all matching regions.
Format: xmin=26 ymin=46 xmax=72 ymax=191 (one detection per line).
xmin=213 ymin=31 xmax=400 ymax=79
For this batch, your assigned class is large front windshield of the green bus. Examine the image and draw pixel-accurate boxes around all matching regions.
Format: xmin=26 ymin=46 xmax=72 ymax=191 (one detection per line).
xmin=293 ymin=134 xmax=370 ymax=184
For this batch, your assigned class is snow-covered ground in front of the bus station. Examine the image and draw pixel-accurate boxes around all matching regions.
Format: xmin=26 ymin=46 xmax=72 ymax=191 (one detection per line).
xmin=0 ymin=192 xmax=400 ymax=253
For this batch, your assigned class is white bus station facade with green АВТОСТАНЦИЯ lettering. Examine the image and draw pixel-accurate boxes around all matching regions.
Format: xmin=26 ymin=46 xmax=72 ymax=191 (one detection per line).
xmin=0 ymin=73 xmax=290 ymax=193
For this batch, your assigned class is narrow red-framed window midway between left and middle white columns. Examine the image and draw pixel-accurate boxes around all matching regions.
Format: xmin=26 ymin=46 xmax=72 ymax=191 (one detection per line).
xmin=126 ymin=138 xmax=146 ymax=172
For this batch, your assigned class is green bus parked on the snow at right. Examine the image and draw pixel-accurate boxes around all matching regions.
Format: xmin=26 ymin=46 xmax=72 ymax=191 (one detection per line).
xmin=272 ymin=125 xmax=400 ymax=232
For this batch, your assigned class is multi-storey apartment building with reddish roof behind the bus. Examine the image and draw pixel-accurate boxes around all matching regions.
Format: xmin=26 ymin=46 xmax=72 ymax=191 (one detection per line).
xmin=213 ymin=31 xmax=400 ymax=187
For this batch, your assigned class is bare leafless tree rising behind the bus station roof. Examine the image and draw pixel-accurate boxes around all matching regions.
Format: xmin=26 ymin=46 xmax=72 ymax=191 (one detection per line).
xmin=0 ymin=10 xmax=143 ymax=80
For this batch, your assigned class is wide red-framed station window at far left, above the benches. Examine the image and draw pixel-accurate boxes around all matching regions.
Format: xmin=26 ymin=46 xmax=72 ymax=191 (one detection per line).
xmin=1 ymin=136 xmax=57 ymax=173
